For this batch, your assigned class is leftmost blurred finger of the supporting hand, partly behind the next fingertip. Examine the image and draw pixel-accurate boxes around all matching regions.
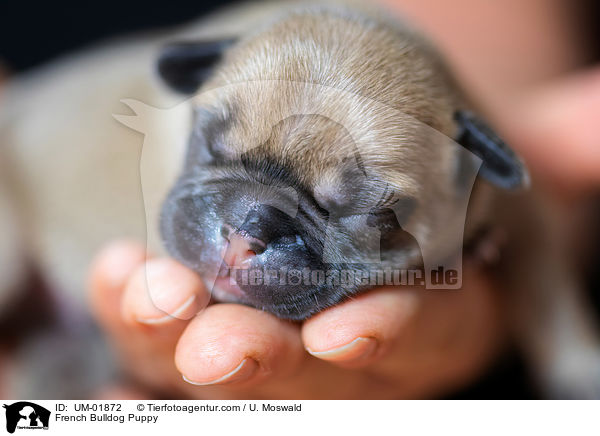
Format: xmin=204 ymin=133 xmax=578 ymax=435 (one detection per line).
xmin=88 ymin=241 xmax=146 ymax=330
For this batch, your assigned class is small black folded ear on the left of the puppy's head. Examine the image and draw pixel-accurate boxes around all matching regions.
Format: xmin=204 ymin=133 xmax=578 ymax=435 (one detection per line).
xmin=157 ymin=38 xmax=235 ymax=94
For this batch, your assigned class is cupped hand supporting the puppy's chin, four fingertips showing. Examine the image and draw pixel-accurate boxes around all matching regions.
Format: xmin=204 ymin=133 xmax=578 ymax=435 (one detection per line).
xmin=90 ymin=242 xmax=503 ymax=399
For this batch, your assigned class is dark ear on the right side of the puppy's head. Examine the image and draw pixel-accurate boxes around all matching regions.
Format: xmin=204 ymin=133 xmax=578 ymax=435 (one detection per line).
xmin=454 ymin=110 xmax=529 ymax=189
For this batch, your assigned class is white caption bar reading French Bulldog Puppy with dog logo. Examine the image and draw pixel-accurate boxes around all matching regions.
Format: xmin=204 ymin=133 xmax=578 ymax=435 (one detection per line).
xmin=0 ymin=400 xmax=600 ymax=436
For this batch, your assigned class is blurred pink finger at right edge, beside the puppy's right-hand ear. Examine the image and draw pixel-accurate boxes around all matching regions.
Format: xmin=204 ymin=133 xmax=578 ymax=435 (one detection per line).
xmin=506 ymin=68 xmax=600 ymax=187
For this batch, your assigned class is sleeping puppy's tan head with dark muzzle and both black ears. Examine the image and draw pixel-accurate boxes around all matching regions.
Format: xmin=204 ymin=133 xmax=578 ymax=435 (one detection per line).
xmin=159 ymin=9 xmax=524 ymax=319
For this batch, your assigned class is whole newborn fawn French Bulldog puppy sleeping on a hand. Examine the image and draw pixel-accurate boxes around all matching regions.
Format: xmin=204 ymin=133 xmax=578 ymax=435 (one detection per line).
xmin=2 ymin=3 xmax=600 ymax=397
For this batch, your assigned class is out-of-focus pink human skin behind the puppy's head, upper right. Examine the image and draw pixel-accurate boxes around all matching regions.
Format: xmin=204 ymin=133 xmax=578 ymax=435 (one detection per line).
xmin=382 ymin=0 xmax=600 ymax=191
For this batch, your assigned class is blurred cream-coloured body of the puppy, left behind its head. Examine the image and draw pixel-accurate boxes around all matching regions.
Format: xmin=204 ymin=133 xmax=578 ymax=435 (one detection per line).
xmin=0 ymin=2 xmax=286 ymax=303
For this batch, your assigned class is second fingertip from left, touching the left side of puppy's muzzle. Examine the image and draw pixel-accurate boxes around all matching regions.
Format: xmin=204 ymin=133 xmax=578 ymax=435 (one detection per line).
xmin=122 ymin=258 xmax=210 ymax=326
